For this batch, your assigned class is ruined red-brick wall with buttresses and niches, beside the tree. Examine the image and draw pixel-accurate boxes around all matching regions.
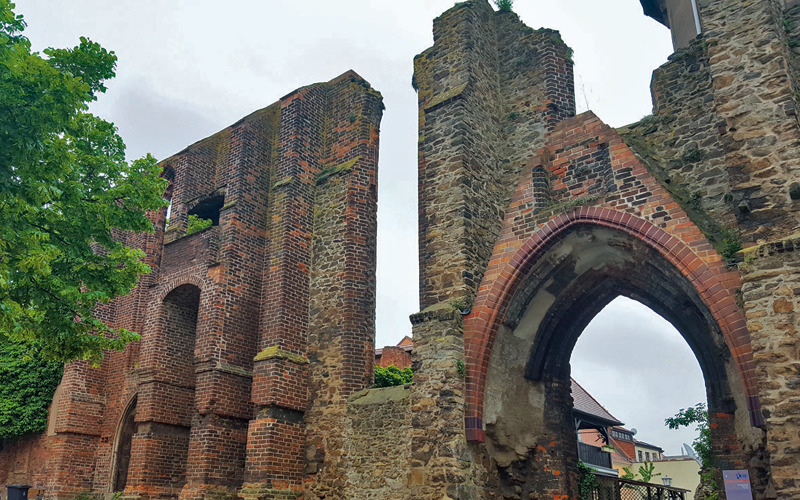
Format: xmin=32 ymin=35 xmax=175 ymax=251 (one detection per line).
xmin=0 ymin=72 xmax=382 ymax=499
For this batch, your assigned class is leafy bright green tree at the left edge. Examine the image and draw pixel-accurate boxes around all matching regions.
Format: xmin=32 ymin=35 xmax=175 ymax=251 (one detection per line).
xmin=0 ymin=0 xmax=166 ymax=361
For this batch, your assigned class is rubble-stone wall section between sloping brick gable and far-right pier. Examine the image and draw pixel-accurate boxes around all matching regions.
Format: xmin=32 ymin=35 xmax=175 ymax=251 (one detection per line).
xmin=619 ymin=39 xmax=741 ymax=250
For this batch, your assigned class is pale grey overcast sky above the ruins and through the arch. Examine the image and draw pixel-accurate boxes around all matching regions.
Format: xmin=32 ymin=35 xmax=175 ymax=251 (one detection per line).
xmin=16 ymin=0 xmax=705 ymax=454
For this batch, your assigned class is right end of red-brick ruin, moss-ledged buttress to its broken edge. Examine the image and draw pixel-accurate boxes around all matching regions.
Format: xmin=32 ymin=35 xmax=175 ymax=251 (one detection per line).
xmin=239 ymin=72 xmax=382 ymax=499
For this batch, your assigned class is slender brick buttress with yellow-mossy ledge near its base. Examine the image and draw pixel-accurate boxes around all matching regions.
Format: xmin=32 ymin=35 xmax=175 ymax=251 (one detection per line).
xmin=240 ymin=85 xmax=327 ymax=499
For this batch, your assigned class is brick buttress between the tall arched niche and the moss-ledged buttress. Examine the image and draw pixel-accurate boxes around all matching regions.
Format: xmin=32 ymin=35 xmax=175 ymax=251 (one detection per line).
xmin=181 ymin=113 xmax=280 ymax=500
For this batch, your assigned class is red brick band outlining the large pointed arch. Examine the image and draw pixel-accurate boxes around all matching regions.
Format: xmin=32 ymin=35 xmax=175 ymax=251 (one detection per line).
xmin=464 ymin=207 xmax=763 ymax=442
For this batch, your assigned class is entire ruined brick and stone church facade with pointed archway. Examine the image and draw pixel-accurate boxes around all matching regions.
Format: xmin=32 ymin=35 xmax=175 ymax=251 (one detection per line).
xmin=0 ymin=0 xmax=800 ymax=500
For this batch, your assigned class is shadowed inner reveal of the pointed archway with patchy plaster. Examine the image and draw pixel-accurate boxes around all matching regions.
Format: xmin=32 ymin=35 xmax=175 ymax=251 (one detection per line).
xmin=472 ymin=221 xmax=763 ymax=498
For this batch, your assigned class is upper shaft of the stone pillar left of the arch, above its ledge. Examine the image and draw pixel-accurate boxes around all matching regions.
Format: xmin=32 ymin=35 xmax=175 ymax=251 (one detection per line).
xmin=414 ymin=2 xmax=575 ymax=309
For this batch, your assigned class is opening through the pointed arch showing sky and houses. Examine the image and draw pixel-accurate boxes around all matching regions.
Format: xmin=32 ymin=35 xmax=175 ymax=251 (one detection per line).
xmin=570 ymin=296 xmax=708 ymax=492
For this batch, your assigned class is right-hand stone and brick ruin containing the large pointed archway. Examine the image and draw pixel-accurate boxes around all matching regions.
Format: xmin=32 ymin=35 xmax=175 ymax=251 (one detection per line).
xmin=411 ymin=0 xmax=800 ymax=498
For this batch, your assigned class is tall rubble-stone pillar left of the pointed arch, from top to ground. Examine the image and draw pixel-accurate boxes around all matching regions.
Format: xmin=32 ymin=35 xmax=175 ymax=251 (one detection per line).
xmin=409 ymin=0 xmax=575 ymax=499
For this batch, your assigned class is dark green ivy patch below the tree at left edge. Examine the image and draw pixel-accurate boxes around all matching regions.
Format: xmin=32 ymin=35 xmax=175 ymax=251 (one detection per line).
xmin=0 ymin=339 xmax=64 ymax=439
